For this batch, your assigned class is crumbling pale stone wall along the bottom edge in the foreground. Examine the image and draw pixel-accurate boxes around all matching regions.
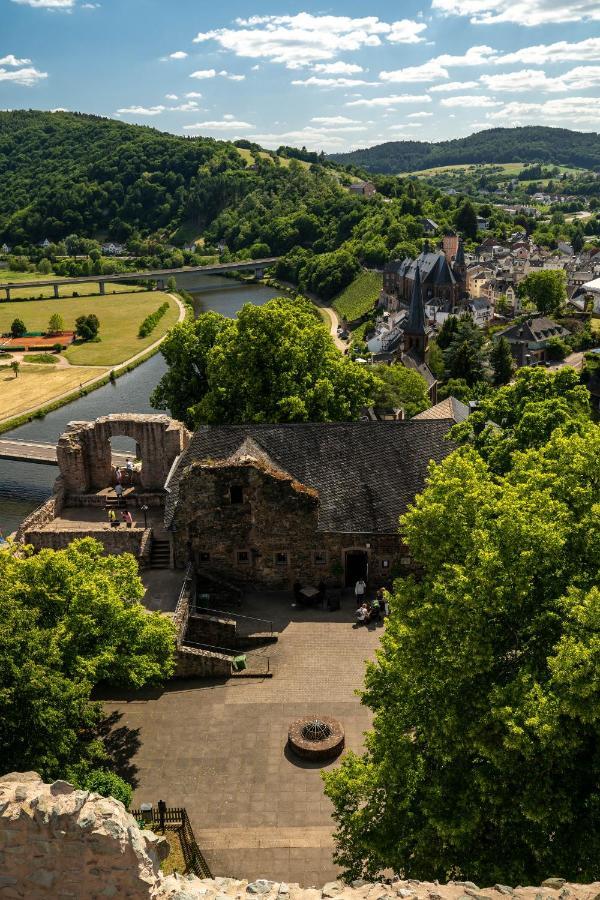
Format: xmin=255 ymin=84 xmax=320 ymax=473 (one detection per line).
xmin=0 ymin=772 xmax=600 ymax=900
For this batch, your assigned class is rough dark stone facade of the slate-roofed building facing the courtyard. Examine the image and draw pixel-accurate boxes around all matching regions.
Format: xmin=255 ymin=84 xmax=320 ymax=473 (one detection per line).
xmin=175 ymin=460 xmax=408 ymax=589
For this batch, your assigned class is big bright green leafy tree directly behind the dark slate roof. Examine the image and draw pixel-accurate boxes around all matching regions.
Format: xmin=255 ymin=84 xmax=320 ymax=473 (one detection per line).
xmin=151 ymin=298 xmax=377 ymax=427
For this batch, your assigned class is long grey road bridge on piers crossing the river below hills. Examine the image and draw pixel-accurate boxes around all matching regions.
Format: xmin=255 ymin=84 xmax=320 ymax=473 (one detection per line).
xmin=0 ymin=256 xmax=279 ymax=300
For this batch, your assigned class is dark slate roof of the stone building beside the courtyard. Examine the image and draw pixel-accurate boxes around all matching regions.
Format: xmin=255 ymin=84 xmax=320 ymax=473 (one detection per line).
xmin=165 ymin=419 xmax=454 ymax=534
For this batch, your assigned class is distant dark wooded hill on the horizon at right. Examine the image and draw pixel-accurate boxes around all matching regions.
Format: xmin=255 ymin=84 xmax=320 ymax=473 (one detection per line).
xmin=329 ymin=126 xmax=600 ymax=174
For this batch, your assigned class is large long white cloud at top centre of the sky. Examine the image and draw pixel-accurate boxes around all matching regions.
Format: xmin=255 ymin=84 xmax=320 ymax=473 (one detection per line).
xmin=194 ymin=12 xmax=427 ymax=69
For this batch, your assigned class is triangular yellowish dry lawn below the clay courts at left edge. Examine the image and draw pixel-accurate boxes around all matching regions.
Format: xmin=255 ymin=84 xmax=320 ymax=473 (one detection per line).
xmin=0 ymin=366 xmax=107 ymax=419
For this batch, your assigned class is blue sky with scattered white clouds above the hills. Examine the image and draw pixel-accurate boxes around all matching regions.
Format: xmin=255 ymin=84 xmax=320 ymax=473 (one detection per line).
xmin=0 ymin=0 xmax=600 ymax=153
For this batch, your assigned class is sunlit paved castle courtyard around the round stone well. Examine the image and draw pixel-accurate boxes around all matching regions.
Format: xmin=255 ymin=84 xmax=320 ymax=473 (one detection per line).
xmin=105 ymin=595 xmax=381 ymax=886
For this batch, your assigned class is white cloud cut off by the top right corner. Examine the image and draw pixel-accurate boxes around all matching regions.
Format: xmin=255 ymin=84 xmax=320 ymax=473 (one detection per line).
xmin=431 ymin=0 xmax=600 ymax=26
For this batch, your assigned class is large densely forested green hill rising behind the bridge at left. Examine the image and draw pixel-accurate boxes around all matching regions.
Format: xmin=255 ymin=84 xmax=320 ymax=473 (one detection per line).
xmin=0 ymin=110 xmax=352 ymax=252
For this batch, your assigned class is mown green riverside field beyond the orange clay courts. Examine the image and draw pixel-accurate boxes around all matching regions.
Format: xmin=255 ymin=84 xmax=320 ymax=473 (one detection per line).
xmin=0 ymin=291 xmax=179 ymax=366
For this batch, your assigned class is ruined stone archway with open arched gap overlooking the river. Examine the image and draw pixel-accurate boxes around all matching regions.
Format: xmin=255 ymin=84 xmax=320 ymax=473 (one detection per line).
xmin=56 ymin=413 xmax=190 ymax=494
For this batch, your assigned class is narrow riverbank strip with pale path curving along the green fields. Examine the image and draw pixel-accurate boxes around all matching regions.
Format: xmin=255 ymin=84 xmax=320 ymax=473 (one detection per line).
xmin=0 ymin=293 xmax=189 ymax=434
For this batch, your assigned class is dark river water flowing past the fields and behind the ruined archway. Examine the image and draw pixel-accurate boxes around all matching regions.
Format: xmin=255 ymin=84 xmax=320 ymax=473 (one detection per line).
xmin=0 ymin=274 xmax=277 ymax=535
